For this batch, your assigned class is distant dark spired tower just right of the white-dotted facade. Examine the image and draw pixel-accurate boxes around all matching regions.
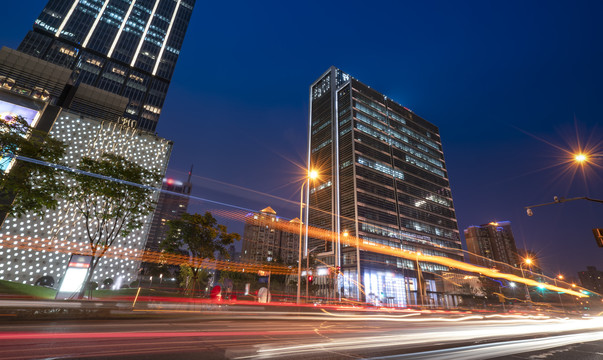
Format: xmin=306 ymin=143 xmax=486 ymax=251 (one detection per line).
xmin=146 ymin=172 xmax=192 ymax=251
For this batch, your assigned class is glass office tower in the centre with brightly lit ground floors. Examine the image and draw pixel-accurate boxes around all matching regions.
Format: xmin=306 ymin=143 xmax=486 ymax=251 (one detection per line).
xmin=304 ymin=67 xmax=463 ymax=306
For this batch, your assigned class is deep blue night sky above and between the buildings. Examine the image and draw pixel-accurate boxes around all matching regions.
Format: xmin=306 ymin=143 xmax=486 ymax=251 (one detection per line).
xmin=0 ymin=0 xmax=603 ymax=277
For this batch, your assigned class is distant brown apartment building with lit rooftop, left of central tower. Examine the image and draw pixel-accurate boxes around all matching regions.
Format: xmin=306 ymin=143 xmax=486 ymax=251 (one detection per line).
xmin=241 ymin=206 xmax=299 ymax=264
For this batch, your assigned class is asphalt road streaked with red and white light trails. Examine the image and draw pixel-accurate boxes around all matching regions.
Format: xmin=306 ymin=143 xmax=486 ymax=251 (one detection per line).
xmin=0 ymin=312 xmax=603 ymax=360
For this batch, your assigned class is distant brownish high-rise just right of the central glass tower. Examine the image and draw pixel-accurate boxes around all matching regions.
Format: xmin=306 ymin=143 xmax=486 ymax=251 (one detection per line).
xmin=464 ymin=221 xmax=519 ymax=271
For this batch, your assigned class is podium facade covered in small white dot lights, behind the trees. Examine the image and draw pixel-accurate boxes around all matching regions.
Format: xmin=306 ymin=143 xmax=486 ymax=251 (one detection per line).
xmin=0 ymin=111 xmax=172 ymax=288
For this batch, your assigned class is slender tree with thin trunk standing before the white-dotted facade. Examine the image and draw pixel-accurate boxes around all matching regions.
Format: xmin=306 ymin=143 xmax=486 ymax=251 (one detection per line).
xmin=67 ymin=154 xmax=161 ymax=297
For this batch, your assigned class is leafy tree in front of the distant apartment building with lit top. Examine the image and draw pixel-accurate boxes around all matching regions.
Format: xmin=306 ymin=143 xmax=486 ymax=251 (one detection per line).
xmin=161 ymin=211 xmax=241 ymax=293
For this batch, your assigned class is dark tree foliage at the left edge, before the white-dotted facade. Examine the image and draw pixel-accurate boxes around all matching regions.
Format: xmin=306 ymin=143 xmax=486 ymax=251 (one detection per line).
xmin=0 ymin=116 xmax=67 ymax=221
